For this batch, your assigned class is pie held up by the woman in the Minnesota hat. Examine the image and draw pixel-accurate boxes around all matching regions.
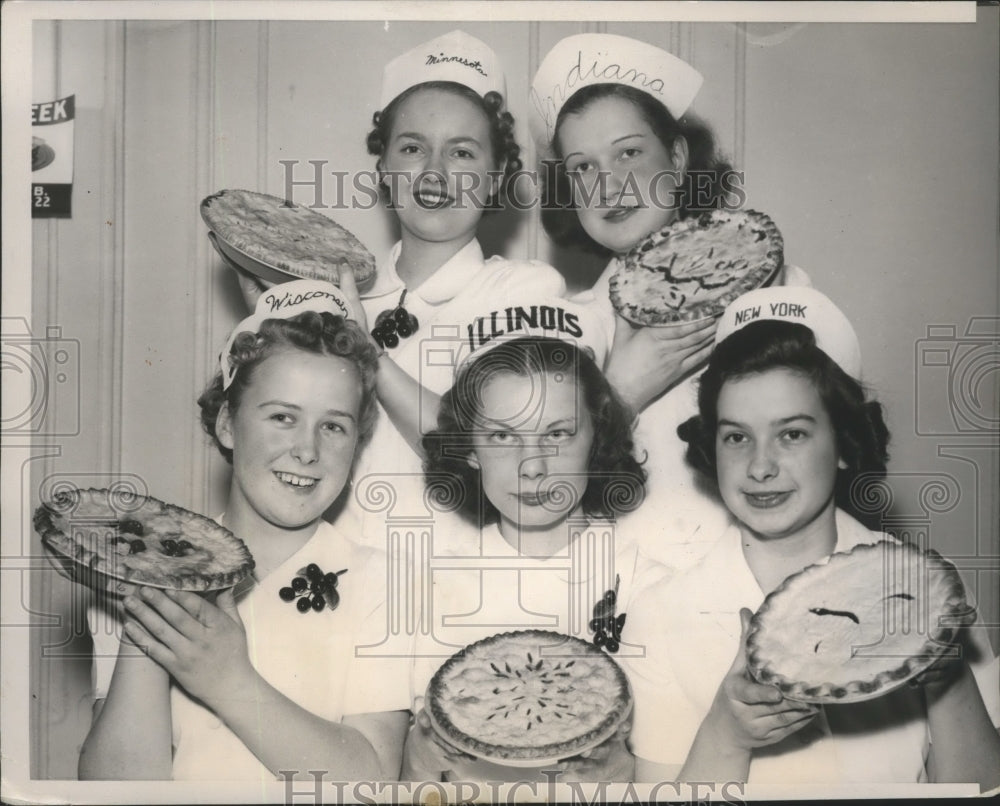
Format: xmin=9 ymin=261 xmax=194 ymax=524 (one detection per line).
xmin=201 ymin=190 xmax=375 ymax=286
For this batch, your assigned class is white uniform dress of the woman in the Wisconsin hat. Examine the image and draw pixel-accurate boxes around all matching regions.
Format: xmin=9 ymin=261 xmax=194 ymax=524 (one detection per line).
xmin=87 ymin=522 xmax=410 ymax=782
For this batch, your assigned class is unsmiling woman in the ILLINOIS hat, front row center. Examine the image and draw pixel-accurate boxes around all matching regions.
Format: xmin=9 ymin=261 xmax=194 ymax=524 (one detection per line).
xmin=403 ymin=298 xmax=666 ymax=781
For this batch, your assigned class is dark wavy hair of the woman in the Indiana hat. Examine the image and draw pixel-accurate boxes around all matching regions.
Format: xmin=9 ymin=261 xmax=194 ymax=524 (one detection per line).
xmin=542 ymin=84 xmax=742 ymax=256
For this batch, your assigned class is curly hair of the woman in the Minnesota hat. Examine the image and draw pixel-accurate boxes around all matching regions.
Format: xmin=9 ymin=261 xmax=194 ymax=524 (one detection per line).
xmin=367 ymin=81 xmax=522 ymax=210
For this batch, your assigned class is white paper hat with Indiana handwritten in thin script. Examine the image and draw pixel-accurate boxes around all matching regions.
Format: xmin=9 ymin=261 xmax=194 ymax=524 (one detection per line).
xmin=528 ymin=34 xmax=702 ymax=145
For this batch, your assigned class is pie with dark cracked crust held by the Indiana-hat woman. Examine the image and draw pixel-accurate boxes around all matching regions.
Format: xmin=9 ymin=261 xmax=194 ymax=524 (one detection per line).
xmin=610 ymin=210 xmax=784 ymax=326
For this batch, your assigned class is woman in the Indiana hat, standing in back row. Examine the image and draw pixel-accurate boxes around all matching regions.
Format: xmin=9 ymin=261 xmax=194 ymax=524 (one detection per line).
xmin=529 ymin=34 xmax=808 ymax=566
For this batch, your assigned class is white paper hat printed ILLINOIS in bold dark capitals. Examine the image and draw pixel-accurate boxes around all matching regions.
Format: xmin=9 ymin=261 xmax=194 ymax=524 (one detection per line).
xmin=455 ymin=294 xmax=609 ymax=374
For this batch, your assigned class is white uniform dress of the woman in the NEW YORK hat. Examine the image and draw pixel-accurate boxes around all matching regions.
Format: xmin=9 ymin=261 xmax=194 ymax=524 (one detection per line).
xmin=626 ymin=510 xmax=1000 ymax=785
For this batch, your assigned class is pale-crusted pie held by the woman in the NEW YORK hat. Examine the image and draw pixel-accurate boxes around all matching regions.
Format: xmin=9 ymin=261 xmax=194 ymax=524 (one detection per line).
xmin=747 ymin=541 xmax=975 ymax=703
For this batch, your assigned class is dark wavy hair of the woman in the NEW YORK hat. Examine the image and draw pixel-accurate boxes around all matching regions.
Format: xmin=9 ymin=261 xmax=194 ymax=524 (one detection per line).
xmin=677 ymin=320 xmax=889 ymax=526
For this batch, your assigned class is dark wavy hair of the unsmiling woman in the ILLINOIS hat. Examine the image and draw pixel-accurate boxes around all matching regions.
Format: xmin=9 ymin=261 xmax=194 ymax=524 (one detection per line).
xmin=423 ymin=336 xmax=646 ymax=525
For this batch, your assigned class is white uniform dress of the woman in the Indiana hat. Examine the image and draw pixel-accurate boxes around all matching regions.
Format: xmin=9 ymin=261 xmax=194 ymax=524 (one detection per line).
xmin=574 ymin=258 xmax=811 ymax=569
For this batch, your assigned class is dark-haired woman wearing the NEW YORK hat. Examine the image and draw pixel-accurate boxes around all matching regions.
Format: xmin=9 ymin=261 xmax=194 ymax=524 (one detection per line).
xmin=627 ymin=288 xmax=1000 ymax=788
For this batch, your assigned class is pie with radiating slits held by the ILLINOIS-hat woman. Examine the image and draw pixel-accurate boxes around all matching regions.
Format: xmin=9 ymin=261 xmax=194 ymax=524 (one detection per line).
xmin=426 ymin=630 xmax=632 ymax=766
